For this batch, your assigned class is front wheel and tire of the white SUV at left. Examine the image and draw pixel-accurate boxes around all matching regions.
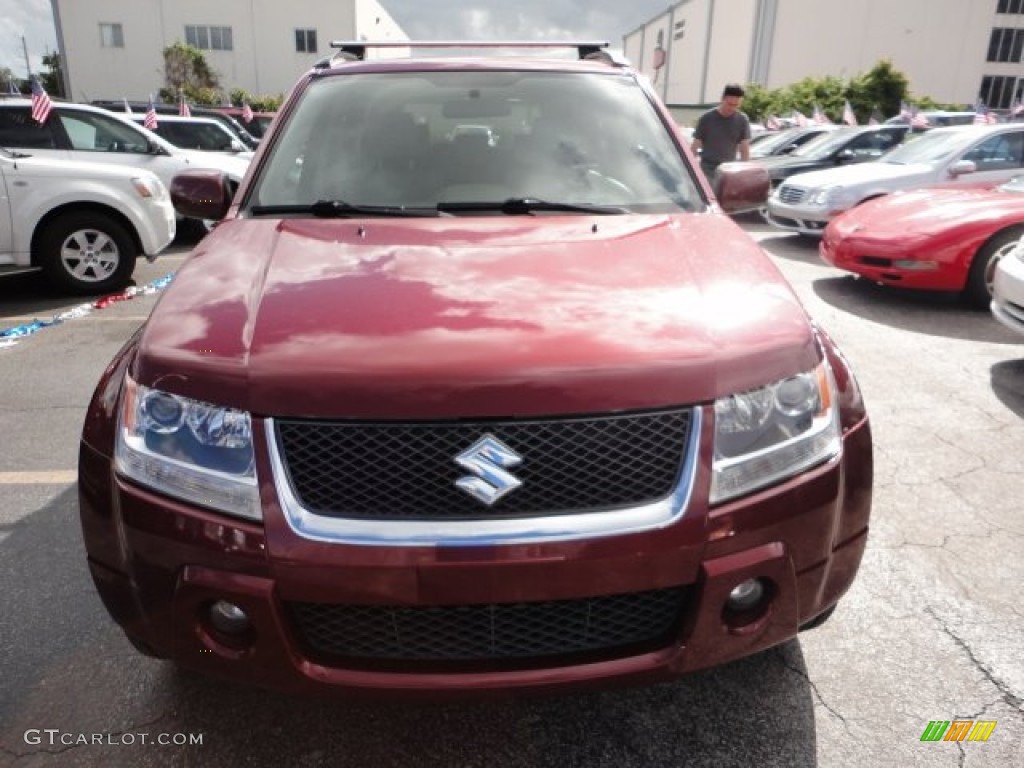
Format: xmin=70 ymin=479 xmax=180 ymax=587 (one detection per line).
xmin=39 ymin=212 xmax=138 ymax=295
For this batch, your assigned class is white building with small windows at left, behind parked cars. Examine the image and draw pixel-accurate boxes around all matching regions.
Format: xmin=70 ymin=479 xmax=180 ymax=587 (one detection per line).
xmin=50 ymin=0 xmax=409 ymax=101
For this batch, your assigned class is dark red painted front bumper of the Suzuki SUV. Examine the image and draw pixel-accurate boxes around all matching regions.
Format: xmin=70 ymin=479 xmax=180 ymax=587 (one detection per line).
xmin=79 ymin=421 xmax=871 ymax=695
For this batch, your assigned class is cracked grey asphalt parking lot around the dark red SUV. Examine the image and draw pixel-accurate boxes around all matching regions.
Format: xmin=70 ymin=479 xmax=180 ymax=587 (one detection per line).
xmin=0 ymin=218 xmax=1024 ymax=768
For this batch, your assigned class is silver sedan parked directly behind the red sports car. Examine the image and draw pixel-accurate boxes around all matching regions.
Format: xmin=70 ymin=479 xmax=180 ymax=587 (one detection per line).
xmin=765 ymin=123 xmax=1024 ymax=237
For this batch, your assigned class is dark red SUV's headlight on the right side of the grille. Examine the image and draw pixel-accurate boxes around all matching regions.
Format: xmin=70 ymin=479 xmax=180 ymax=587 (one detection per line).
xmin=711 ymin=362 xmax=842 ymax=504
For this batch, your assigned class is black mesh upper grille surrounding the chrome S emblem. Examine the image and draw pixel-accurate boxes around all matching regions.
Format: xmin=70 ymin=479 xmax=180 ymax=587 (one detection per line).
xmin=276 ymin=410 xmax=690 ymax=519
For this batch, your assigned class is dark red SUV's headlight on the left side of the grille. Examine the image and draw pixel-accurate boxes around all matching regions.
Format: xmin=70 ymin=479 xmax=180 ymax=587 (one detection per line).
xmin=115 ymin=377 xmax=262 ymax=520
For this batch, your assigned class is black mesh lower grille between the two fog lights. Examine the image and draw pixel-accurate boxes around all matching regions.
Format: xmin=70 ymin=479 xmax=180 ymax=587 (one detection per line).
xmin=287 ymin=588 xmax=684 ymax=662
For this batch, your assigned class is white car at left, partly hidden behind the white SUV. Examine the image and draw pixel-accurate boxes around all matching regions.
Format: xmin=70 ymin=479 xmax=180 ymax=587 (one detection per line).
xmin=0 ymin=98 xmax=249 ymax=228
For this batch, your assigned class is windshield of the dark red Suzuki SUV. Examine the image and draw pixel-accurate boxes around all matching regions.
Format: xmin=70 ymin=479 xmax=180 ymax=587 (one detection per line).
xmin=245 ymin=71 xmax=705 ymax=215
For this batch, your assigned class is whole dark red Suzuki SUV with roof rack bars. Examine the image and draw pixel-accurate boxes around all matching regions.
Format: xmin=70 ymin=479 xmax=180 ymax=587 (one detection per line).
xmin=79 ymin=44 xmax=871 ymax=694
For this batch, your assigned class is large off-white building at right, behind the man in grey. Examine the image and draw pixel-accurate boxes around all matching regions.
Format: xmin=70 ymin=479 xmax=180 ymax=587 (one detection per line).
xmin=623 ymin=0 xmax=1024 ymax=118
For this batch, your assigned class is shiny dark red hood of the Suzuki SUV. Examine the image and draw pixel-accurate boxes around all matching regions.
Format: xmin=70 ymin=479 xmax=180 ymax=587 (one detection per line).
xmin=134 ymin=214 xmax=820 ymax=419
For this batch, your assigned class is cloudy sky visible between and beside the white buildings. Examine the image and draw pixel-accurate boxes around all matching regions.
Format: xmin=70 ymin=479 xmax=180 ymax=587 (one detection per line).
xmin=0 ymin=0 xmax=673 ymax=78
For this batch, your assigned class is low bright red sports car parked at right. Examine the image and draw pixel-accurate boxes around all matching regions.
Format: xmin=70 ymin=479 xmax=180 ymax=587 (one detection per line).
xmin=819 ymin=176 xmax=1024 ymax=307
